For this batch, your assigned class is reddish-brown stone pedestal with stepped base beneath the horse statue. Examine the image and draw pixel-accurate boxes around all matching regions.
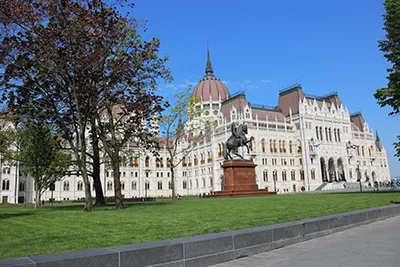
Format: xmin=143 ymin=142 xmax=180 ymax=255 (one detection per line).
xmin=212 ymin=160 xmax=276 ymax=197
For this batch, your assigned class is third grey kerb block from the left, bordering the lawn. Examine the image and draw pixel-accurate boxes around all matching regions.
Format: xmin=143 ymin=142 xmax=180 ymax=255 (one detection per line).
xmin=109 ymin=240 xmax=183 ymax=267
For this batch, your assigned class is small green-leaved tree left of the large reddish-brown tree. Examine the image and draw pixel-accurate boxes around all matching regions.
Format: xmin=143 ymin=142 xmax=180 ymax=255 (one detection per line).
xmin=19 ymin=123 xmax=71 ymax=210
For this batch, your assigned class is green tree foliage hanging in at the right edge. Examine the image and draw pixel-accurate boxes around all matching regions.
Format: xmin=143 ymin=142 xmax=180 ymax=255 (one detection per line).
xmin=374 ymin=0 xmax=400 ymax=160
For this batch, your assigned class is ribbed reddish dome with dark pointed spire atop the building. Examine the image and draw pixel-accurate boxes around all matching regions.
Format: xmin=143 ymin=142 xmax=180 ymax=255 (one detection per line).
xmin=192 ymin=51 xmax=230 ymax=102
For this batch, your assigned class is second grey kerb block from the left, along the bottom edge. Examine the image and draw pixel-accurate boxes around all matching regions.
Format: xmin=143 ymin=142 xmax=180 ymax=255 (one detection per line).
xmin=29 ymin=248 xmax=118 ymax=267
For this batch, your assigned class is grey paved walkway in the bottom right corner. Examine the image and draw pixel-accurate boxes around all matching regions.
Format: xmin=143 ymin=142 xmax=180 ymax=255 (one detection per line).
xmin=215 ymin=216 xmax=400 ymax=267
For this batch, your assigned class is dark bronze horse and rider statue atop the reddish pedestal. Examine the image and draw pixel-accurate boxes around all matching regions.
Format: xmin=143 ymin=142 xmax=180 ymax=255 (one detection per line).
xmin=223 ymin=123 xmax=252 ymax=160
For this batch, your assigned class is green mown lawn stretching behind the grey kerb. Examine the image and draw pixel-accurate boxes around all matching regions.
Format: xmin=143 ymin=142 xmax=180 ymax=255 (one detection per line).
xmin=0 ymin=192 xmax=400 ymax=259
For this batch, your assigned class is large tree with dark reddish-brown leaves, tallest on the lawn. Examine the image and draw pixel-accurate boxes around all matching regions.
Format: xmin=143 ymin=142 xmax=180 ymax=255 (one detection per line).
xmin=0 ymin=0 xmax=169 ymax=210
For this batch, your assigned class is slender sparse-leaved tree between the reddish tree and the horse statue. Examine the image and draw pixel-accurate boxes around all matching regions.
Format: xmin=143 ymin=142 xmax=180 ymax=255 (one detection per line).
xmin=159 ymin=87 xmax=217 ymax=199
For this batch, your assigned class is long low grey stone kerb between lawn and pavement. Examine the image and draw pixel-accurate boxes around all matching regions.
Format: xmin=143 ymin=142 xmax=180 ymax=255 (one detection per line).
xmin=0 ymin=205 xmax=400 ymax=267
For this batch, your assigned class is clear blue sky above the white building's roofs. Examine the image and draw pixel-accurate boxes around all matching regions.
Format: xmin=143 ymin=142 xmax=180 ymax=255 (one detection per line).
xmin=130 ymin=0 xmax=400 ymax=176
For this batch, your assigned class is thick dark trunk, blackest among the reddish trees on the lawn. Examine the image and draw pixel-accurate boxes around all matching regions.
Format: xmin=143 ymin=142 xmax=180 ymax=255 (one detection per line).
xmin=91 ymin=122 xmax=106 ymax=206
